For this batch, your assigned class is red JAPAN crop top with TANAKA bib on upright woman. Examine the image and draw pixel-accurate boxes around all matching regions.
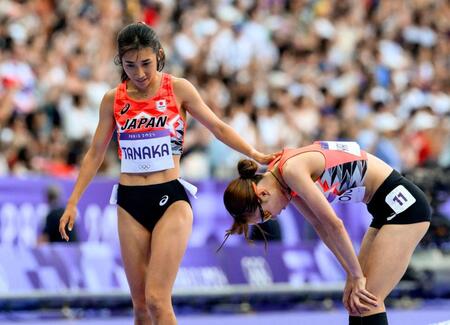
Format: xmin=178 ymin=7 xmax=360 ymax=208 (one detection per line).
xmin=114 ymin=73 xmax=185 ymax=173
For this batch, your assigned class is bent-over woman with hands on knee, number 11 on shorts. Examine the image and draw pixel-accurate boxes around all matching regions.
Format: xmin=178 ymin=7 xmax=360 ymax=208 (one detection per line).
xmin=224 ymin=141 xmax=431 ymax=325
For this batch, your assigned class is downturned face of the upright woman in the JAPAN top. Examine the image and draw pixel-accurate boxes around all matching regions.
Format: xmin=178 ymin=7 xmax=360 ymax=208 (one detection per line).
xmin=122 ymin=47 xmax=157 ymax=90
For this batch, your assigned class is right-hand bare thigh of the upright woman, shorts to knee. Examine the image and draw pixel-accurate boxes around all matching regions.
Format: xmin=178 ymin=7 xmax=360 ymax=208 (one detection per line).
xmin=146 ymin=201 xmax=193 ymax=295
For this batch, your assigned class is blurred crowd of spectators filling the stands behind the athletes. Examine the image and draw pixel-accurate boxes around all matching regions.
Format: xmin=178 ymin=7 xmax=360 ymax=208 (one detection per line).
xmin=0 ymin=0 xmax=450 ymax=180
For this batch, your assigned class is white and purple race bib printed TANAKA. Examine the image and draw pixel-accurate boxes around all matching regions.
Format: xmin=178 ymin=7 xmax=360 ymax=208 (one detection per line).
xmin=120 ymin=130 xmax=175 ymax=173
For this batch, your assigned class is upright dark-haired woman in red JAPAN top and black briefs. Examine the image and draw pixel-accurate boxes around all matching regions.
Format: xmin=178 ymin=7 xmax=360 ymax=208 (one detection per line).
xmin=59 ymin=23 xmax=275 ymax=325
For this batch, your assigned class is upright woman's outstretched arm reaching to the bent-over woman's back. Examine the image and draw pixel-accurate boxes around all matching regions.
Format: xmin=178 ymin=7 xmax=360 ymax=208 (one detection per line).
xmin=173 ymin=78 xmax=275 ymax=164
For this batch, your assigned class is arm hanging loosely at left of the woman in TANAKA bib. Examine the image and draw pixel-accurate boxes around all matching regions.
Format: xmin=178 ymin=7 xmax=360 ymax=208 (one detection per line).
xmin=59 ymin=89 xmax=116 ymax=240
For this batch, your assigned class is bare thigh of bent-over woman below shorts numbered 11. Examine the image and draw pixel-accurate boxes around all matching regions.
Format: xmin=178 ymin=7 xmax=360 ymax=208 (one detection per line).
xmin=363 ymin=222 xmax=430 ymax=300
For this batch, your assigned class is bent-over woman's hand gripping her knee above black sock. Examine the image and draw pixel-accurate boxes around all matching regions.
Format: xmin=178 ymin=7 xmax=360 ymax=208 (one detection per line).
xmin=343 ymin=277 xmax=378 ymax=315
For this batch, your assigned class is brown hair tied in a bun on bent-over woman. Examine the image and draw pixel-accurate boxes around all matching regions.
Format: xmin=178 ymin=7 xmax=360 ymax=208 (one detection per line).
xmin=217 ymin=159 xmax=267 ymax=251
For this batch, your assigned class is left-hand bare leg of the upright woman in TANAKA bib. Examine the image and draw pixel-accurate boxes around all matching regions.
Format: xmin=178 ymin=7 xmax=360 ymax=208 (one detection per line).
xmin=117 ymin=206 xmax=152 ymax=325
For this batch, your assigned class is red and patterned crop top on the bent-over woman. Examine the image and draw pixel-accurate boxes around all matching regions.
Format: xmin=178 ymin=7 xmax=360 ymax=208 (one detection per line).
xmin=269 ymin=141 xmax=367 ymax=203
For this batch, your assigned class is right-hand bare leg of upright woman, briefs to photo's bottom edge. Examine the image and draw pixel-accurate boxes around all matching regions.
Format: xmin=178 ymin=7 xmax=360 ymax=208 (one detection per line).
xmin=145 ymin=201 xmax=193 ymax=325
